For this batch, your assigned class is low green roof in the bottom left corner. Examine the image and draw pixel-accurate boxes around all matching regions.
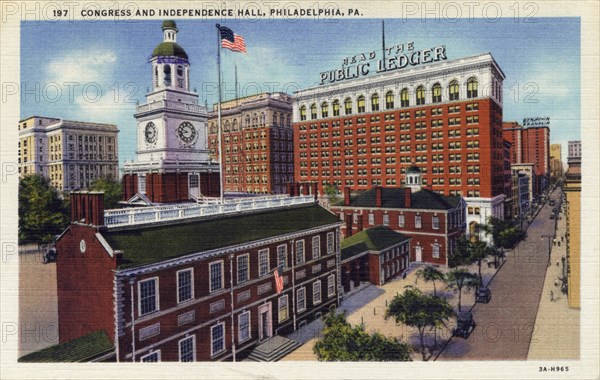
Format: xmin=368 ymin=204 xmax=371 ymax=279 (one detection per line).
xmin=19 ymin=330 xmax=114 ymax=363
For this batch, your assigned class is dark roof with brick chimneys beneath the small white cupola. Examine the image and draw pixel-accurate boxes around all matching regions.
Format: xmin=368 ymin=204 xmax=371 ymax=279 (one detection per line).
xmin=335 ymin=187 xmax=461 ymax=210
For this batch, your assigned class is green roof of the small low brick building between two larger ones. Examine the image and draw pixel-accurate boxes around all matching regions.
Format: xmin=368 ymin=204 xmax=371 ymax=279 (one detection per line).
xmin=342 ymin=226 xmax=410 ymax=260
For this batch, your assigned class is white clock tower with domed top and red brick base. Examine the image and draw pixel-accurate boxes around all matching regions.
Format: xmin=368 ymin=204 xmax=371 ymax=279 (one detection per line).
xmin=123 ymin=20 xmax=220 ymax=204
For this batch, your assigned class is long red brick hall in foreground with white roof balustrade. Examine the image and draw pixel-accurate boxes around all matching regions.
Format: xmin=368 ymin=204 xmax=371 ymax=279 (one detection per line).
xmin=56 ymin=193 xmax=341 ymax=361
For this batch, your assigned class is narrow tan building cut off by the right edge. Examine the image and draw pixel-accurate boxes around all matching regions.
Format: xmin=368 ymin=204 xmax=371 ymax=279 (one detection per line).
xmin=564 ymin=141 xmax=581 ymax=309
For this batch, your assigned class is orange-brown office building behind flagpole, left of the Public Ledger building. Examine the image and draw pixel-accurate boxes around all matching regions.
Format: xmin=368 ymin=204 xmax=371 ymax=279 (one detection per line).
xmin=208 ymin=92 xmax=294 ymax=194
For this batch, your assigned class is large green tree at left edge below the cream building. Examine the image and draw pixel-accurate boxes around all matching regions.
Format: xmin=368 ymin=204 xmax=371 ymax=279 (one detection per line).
xmin=19 ymin=174 xmax=70 ymax=243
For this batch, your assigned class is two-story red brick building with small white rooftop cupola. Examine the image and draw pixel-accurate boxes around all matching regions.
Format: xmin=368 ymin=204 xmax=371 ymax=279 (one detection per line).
xmin=331 ymin=167 xmax=464 ymax=265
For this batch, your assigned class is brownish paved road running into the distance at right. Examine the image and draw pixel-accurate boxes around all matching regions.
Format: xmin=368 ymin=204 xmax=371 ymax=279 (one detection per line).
xmin=437 ymin=189 xmax=560 ymax=360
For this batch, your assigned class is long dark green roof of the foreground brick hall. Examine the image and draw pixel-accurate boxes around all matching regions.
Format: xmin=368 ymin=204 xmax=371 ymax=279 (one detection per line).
xmin=102 ymin=204 xmax=339 ymax=268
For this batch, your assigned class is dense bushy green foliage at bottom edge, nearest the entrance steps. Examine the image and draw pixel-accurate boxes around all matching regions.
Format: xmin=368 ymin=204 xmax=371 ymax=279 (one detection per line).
xmin=313 ymin=313 xmax=411 ymax=361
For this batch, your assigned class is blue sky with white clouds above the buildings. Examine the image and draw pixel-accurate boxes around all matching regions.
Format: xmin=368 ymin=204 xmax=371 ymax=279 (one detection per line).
xmin=21 ymin=18 xmax=581 ymax=164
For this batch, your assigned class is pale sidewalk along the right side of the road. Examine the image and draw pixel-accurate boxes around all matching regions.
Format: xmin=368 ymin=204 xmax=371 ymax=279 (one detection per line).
xmin=527 ymin=196 xmax=580 ymax=360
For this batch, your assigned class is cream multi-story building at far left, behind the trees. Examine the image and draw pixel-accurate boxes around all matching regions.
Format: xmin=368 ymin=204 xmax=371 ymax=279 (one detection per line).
xmin=18 ymin=116 xmax=119 ymax=191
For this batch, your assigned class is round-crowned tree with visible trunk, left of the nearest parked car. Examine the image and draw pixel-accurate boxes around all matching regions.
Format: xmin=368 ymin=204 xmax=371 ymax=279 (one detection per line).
xmin=385 ymin=286 xmax=454 ymax=361
